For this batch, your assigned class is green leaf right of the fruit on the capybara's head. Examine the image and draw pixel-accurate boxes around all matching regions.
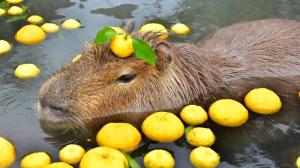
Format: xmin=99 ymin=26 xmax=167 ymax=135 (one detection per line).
xmin=132 ymin=39 xmax=156 ymax=65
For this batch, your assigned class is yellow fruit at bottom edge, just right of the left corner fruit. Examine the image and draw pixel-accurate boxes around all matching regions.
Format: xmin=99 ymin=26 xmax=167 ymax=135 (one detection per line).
xmin=21 ymin=152 xmax=51 ymax=168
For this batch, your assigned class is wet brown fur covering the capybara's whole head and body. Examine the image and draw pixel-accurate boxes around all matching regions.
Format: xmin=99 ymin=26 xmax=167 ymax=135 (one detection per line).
xmin=39 ymin=19 xmax=300 ymax=127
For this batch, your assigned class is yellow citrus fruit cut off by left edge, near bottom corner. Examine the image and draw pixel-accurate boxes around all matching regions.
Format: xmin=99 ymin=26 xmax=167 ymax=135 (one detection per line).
xmin=0 ymin=137 xmax=16 ymax=168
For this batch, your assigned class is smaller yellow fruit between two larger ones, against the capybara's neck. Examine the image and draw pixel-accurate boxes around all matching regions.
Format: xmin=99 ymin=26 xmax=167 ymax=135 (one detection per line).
xmin=180 ymin=105 xmax=208 ymax=125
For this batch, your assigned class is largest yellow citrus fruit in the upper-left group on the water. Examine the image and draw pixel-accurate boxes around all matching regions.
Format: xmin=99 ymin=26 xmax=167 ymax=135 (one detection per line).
xmin=15 ymin=25 xmax=46 ymax=45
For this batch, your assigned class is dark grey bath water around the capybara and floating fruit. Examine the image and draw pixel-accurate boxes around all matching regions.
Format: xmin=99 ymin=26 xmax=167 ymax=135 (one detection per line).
xmin=0 ymin=0 xmax=300 ymax=168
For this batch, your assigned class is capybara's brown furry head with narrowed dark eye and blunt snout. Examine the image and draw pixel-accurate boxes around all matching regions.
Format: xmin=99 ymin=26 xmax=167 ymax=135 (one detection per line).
xmin=39 ymin=33 xmax=195 ymax=129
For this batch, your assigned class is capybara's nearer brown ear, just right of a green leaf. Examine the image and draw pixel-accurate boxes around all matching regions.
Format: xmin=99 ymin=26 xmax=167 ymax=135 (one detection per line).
xmin=155 ymin=42 xmax=175 ymax=71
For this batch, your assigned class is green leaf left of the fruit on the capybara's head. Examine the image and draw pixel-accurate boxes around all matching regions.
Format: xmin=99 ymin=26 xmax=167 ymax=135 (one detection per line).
xmin=94 ymin=27 xmax=117 ymax=45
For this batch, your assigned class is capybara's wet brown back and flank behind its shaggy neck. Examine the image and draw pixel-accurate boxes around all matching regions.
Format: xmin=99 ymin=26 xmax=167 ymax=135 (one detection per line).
xmin=199 ymin=19 xmax=300 ymax=98
